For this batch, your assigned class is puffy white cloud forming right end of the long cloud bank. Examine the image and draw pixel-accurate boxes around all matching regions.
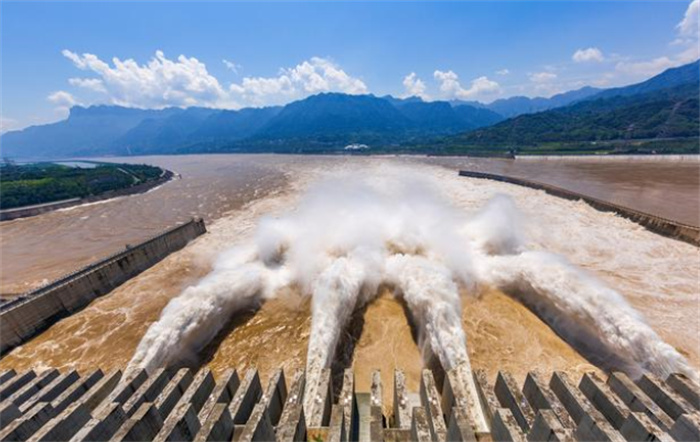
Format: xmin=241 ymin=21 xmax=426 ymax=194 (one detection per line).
xmin=229 ymin=57 xmax=368 ymax=104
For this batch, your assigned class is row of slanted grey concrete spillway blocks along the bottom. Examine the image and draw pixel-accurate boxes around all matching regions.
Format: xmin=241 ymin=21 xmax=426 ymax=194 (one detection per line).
xmin=0 ymin=368 xmax=700 ymax=442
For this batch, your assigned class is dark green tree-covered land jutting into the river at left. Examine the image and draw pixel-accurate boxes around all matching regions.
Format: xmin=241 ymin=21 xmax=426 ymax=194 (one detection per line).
xmin=0 ymin=163 xmax=163 ymax=209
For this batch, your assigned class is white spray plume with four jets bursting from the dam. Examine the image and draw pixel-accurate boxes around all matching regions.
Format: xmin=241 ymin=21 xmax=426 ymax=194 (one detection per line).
xmin=124 ymin=170 xmax=696 ymax=418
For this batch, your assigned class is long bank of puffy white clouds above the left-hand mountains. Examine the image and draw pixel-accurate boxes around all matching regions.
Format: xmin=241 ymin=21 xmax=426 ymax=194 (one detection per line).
xmin=62 ymin=49 xmax=367 ymax=108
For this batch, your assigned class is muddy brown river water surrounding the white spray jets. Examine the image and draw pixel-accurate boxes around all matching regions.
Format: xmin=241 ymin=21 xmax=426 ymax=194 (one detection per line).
xmin=0 ymin=155 xmax=700 ymax=388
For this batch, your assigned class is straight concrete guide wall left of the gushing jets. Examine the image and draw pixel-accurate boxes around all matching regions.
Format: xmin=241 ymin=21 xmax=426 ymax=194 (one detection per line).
xmin=0 ymin=219 xmax=206 ymax=354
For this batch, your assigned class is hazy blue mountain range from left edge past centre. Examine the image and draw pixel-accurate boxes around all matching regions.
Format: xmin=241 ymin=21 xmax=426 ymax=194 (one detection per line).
xmin=2 ymin=93 xmax=503 ymax=158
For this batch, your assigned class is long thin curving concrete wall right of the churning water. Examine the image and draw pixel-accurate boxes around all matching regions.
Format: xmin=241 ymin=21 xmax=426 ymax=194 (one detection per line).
xmin=459 ymin=170 xmax=700 ymax=246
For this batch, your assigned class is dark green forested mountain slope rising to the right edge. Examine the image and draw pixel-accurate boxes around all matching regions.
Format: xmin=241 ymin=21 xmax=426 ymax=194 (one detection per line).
xmin=442 ymin=62 xmax=700 ymax=154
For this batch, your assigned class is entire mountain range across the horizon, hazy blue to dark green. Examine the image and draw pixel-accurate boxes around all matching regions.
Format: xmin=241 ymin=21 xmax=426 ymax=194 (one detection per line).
xmin=0 ymin=61 xmax=700 ymax=158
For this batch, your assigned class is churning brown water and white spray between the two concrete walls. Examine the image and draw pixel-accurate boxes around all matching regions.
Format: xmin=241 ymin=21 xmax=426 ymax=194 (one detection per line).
xmin=0 ymin=157 xmax=700 ymax=408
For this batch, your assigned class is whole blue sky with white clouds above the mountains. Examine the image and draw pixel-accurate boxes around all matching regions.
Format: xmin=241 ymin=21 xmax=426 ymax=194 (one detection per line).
xmin=0 ymin=0 xmax=700 ymax=131
